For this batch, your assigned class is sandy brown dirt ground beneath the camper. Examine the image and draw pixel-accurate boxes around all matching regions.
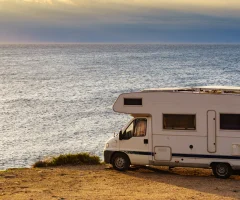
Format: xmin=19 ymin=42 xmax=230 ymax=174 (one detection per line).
xmin=0 ymin=165 xmax=240 ymax=200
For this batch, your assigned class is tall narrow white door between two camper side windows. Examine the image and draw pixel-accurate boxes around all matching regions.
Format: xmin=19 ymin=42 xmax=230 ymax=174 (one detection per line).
xmin=207 ymin=110 xmax=216 ymax=153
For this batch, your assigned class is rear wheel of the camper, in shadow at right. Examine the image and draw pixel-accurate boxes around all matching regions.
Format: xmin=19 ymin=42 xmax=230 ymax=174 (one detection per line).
xmin=212 ymin=163 xmax=232 ymax=179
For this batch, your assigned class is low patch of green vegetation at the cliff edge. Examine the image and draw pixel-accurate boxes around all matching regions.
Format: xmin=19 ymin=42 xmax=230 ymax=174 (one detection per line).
xmin=33 ymin=153 xmax=101 ymax=168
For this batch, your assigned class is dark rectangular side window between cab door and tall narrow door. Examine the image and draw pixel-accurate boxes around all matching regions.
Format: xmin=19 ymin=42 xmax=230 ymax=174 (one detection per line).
xmin=163 ymin=114 xmax=196 ymax=130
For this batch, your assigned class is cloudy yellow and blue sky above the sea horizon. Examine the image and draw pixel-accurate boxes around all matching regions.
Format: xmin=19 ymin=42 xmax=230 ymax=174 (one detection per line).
xmin=0 ymin=0 xmax=240 ymax=43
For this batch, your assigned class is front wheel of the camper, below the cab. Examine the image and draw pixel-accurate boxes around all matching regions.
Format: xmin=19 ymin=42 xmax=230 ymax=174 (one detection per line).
xmin=112 ymin=153 xmax=130 ymax=171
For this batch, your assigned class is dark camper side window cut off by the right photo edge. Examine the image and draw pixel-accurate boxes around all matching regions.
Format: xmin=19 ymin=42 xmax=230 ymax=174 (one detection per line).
xmin=220 ymin=114 xmax=240 ymax=130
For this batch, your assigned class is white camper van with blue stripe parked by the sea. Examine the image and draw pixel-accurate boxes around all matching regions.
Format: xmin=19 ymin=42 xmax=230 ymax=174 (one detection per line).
xmin=104 ymin=86 xmax=240 ymax=178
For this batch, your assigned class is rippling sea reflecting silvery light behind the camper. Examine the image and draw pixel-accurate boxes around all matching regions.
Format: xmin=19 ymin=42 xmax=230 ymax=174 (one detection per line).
xmin=0 ymin=44 xmax=240 ymax=169
